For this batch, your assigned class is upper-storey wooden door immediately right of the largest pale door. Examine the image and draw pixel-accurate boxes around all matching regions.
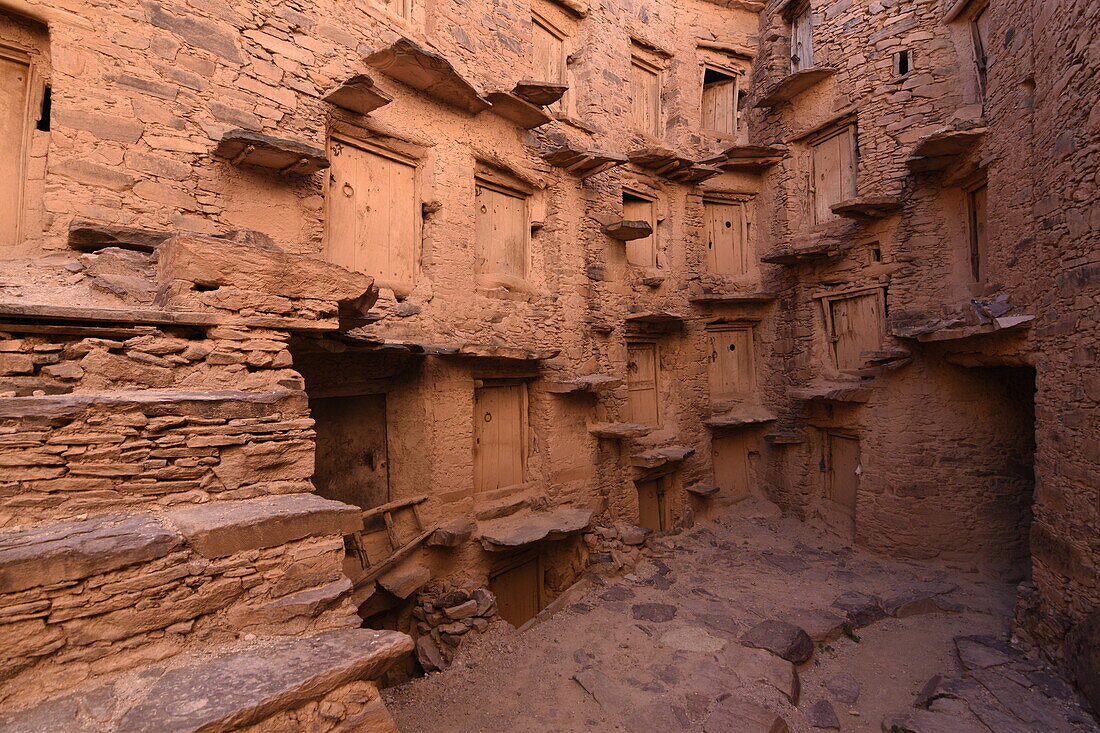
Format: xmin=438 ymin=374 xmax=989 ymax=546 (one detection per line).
xmin=476 ymin=183 xmax=528 ymax=277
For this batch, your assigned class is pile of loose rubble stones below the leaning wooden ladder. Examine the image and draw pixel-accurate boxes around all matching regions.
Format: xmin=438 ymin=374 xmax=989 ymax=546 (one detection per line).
xmin=413 ymin=588 xmax=499 ymax=672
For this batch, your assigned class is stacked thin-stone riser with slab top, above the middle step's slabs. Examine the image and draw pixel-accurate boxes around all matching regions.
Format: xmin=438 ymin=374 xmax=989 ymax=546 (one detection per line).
xmin=0 ymin=392 xmax=314 ymax=526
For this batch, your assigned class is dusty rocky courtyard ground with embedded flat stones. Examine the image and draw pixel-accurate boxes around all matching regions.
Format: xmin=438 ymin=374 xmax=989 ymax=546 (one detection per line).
xmin=385 ymin=502 xmax=1100 ymax=733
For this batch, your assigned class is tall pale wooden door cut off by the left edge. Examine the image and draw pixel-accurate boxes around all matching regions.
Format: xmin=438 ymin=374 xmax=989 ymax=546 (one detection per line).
xmin=0 ymin=55 xmax=31 ymax=247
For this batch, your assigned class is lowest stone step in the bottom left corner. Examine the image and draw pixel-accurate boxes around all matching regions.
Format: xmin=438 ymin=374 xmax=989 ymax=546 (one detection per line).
xmin=0 ymin=628 xmax=413 ymax=733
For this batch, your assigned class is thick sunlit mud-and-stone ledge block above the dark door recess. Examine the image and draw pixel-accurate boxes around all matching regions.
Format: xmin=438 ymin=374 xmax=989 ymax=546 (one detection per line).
xmin=156 ymin=234 xmax=377 ymax=309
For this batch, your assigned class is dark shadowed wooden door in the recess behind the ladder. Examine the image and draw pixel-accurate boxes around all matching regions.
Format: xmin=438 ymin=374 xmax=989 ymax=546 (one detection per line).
xmin=309 ymin=394 xmax=391 ymax=510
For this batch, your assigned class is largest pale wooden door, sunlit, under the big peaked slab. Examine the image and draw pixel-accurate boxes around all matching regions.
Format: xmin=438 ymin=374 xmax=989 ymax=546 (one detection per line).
xmin=326 ymin=139 xmax=420 ymax=283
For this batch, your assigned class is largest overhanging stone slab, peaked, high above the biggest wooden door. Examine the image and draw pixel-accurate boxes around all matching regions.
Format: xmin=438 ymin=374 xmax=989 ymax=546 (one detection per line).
xmin=364 ymin=39 xmax=490 ymax=114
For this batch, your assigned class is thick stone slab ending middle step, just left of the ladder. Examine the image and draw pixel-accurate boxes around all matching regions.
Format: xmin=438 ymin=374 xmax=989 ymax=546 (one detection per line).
xmin=167 ymin=494 xmax=363 ymax=558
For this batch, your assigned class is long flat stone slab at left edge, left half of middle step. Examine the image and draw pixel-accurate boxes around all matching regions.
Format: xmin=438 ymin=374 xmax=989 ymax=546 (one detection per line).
xmin=0 ymin=514 xmax=180 ymax=593
